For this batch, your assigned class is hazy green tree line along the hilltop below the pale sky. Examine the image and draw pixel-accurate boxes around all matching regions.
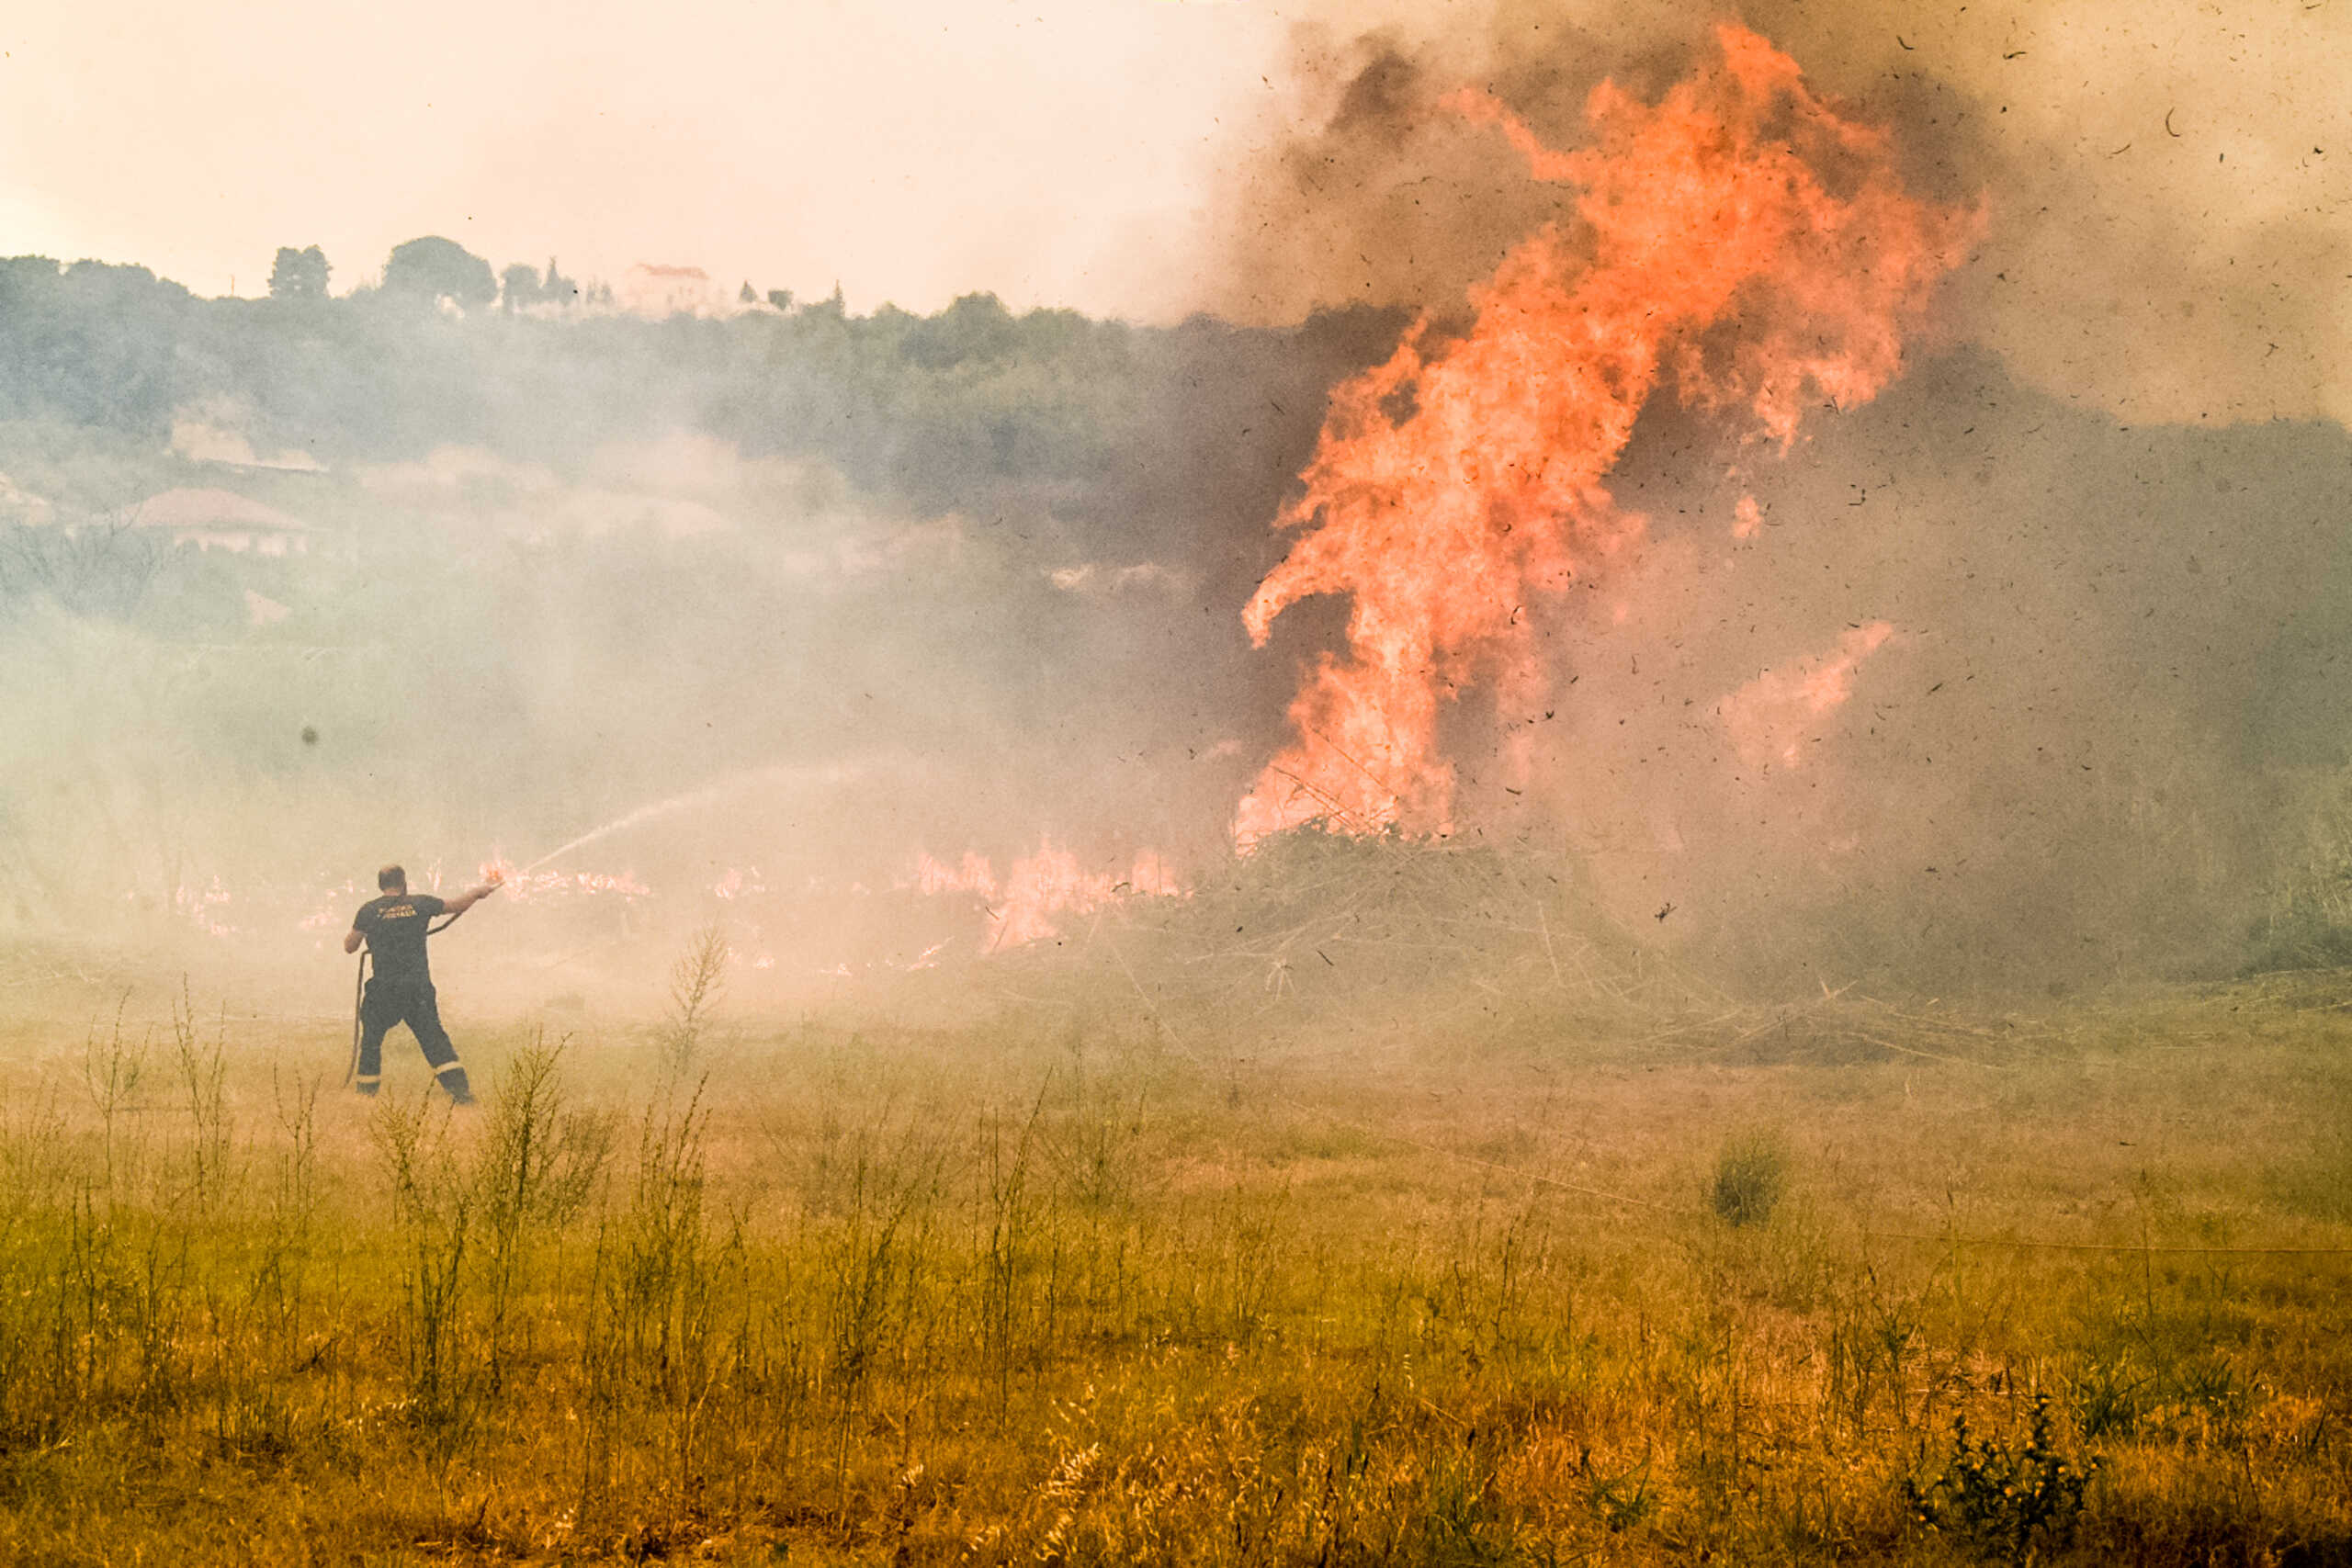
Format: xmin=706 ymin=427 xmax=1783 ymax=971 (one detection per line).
xmin=0 ymin=235 xmax=1402 ymax=526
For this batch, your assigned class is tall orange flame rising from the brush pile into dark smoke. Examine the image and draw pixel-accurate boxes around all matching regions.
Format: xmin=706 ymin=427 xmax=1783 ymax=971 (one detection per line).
xmin=1235 ymin=24 xmax=1975 ymax=846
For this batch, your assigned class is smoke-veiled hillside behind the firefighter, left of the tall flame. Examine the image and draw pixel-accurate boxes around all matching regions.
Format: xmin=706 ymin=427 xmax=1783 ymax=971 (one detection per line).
xmin=0 ymin=285 xmax=1395 ymax=978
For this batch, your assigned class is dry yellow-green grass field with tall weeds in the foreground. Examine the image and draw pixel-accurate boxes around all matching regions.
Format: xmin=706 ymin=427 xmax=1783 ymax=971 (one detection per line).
xmin=0 ymin=976 xmax=2352 ymax=1563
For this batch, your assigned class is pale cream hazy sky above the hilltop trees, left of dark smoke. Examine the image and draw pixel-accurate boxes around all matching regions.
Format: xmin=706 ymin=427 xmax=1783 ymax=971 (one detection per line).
xmin=0 ymin=0 xmax=1282 ymax=310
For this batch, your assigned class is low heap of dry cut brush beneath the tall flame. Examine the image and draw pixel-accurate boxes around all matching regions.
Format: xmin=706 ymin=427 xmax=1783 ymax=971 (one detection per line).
xmin=955 ymin=823 xmax=2069 ymax=1072
